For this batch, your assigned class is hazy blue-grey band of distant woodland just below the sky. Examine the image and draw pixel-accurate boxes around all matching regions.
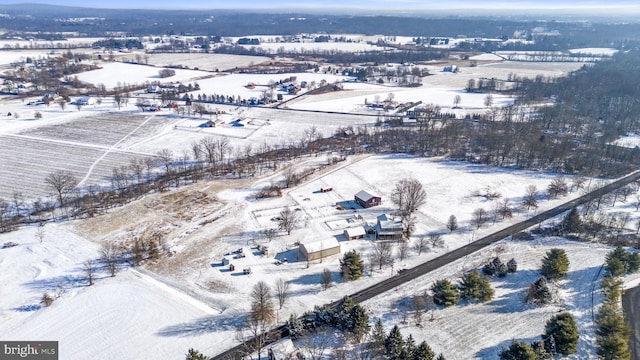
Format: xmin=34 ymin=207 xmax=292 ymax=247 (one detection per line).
xmin=0 ymin=5 xmax=640 ymax=51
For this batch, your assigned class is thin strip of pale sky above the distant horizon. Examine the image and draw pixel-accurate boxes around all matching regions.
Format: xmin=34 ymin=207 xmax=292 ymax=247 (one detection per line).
xmin=0 ymin=0 xmax=639 ymax=10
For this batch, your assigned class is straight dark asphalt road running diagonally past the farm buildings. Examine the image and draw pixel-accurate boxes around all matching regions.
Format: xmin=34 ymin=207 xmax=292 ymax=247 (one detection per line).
xmin=211 ymin=171 xmax=640 ymax=360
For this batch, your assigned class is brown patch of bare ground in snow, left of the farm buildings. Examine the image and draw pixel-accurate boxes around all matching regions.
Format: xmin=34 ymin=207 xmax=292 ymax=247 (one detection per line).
xmin=70 ymin=180 xmax=248 ymax=286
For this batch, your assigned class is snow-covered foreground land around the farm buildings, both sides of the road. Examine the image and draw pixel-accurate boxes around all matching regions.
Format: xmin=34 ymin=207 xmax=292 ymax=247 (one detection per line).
xmin=5 ymin=150 xmax=640 ymax=359
